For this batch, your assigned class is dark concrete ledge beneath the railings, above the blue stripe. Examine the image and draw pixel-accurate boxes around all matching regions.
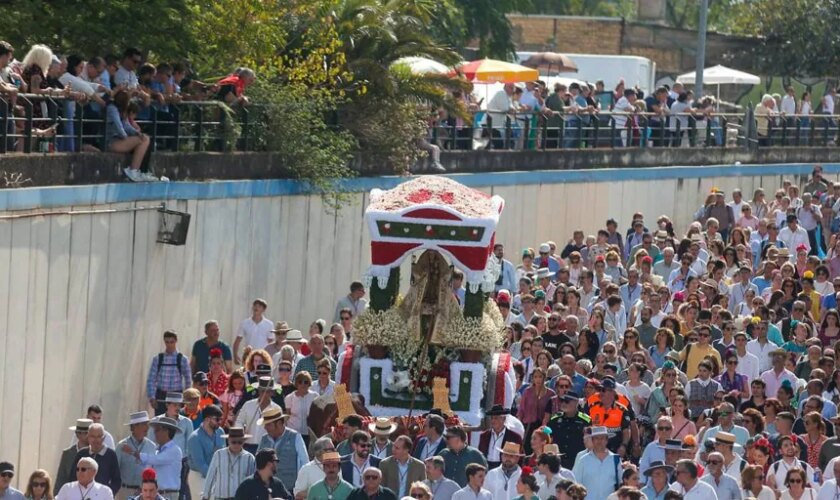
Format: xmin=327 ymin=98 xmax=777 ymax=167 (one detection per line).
xmin=0 ymin=148 xmax=840 ymax=188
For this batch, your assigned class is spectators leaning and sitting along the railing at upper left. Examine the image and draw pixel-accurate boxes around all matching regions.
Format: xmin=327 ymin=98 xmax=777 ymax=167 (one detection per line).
xmin=0 ymin=41 xmax=256 ymax=182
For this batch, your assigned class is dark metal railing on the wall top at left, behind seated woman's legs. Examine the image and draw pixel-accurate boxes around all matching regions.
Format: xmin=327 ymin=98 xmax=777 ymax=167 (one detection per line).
xmin=0 ymin=94 xmax=262 ymax=153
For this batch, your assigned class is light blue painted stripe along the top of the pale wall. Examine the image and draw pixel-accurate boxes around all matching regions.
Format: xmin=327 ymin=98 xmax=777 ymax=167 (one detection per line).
xmin=0 ymin=163 xmax=840 ymax=211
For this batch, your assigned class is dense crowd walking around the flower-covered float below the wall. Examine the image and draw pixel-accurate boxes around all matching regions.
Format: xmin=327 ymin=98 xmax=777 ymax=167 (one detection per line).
xmin=8 ymin=166 xmax=840 ymax=500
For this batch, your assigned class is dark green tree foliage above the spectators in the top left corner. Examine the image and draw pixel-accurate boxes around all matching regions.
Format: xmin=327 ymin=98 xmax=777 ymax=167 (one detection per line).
xmin=0 ymin=0 xmax=191 ymax=60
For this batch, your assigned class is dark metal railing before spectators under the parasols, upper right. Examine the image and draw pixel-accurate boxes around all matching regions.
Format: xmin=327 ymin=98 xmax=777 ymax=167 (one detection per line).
xmin=430 ymin=108 xmax=838 ymax=150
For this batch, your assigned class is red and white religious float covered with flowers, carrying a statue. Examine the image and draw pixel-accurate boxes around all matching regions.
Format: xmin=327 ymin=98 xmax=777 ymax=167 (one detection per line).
xmin=337 ymin=176 xmax=515 ymax=426
